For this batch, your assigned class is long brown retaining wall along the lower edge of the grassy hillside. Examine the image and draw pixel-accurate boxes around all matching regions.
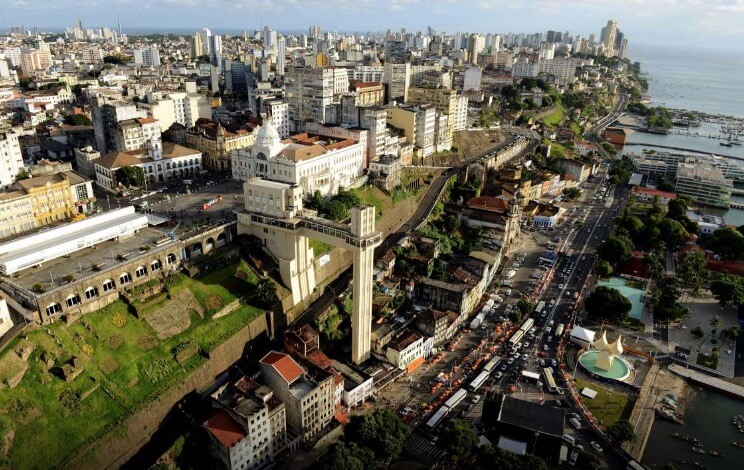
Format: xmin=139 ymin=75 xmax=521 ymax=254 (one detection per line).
xmin=68 ymin=313 xmax=271 ymax=470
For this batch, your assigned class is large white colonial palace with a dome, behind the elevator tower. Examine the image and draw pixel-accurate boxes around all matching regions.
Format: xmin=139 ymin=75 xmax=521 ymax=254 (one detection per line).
xmin=231 ymin=121 xmax=367 ymax=196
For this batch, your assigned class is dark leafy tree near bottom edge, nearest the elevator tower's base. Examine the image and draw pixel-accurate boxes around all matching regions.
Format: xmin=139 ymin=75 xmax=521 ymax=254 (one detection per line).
xmin=344 ymin=408 xmax=411 ymax=459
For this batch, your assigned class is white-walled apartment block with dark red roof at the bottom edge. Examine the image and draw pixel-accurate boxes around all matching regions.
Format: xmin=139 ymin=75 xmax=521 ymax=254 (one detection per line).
xmin=203 ymin=376 xmax=290 ymax=470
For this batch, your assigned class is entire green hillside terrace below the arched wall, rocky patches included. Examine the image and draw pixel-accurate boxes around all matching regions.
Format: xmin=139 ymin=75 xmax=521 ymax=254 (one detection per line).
xmin=0 ymin=261 xmax=262 ymax=469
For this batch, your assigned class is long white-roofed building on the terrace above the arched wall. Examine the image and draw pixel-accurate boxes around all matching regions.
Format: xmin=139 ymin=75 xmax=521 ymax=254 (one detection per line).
xmin=0 ymin=206 xmax=147 ymax=276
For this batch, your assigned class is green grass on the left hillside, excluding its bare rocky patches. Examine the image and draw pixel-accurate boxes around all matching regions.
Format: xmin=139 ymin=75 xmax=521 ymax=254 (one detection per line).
xmin=0 ymin=263 xmax=261 ymax=469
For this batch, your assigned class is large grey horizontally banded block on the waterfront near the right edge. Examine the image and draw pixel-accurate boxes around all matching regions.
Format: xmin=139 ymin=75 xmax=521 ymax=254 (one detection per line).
xmin=674 ymin=163 xmax=734 ymax=208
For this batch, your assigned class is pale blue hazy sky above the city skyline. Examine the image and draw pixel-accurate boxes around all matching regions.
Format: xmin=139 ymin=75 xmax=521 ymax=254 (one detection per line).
xmin=0 ymin=0 xmax=744 ymax=51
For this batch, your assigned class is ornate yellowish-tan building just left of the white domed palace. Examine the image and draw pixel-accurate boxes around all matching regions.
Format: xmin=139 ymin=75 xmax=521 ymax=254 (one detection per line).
xmin=186 ymin=119 xmax=256 ymax=171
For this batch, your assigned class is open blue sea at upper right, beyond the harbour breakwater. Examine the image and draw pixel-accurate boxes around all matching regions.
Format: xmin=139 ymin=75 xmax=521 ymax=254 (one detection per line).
xmin=630 ymin=45 xmax=744 ymax=118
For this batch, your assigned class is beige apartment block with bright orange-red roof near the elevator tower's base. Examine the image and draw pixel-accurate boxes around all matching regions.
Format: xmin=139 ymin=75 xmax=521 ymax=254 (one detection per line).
xmin=259 ymin=351 xmax=335 ymax=441
